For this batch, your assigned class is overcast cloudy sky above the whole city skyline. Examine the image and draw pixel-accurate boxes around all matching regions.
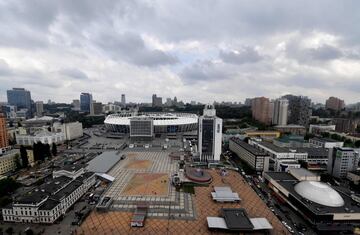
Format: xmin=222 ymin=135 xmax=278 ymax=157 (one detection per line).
xmin=0 ymin=0 xmax=360 ymax=103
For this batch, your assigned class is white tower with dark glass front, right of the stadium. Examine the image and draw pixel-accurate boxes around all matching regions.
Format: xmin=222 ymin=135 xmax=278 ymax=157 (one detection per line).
xmin=198 ymin=105 xmax=222 ymax=162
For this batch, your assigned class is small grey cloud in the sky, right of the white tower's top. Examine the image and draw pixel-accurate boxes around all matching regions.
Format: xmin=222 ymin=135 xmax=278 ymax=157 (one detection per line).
xmin=219 ymin=47 xmax=263 ymax=64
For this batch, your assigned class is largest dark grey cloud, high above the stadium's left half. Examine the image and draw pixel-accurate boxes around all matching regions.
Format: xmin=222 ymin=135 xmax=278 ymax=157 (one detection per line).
xmin=95 ymin=32 xmax=179 ymax=67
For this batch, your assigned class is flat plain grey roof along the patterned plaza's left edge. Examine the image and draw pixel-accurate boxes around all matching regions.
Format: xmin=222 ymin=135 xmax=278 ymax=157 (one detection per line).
xmin=87 ymin=151 xmax=120 ymax=173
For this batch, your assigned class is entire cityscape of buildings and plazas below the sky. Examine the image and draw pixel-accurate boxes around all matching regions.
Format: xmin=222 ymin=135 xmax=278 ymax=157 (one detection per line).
xmin=0 ymin=88 xmax=360 ymax=235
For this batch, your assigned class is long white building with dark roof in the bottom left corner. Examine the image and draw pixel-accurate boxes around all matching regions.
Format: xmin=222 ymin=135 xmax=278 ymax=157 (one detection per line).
xmin=2 ymin=169 xmax=96 ymax=224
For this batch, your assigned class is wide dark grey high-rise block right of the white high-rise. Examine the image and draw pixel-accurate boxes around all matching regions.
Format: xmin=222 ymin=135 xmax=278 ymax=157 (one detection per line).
xmin=282 ymin=95 xmax=311 ymax=126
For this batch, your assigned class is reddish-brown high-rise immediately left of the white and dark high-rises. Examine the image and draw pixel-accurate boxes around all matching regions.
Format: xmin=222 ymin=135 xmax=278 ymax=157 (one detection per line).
xmin=251 ymin=97 xmax=271 ymax=124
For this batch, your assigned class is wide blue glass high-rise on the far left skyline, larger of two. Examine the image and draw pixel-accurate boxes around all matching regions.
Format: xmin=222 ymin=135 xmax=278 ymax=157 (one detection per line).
xmin=7 ymin=88 xmax=31 ymax=116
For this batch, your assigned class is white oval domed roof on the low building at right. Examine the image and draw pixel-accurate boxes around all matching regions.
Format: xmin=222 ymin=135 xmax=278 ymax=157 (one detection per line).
xmin=295 ymin=181 xmax=345 ymax=207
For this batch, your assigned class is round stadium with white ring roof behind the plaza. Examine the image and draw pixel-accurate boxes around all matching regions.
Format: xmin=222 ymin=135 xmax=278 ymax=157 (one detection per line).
xmin=104 ymin=112 xmax=198 ymax=135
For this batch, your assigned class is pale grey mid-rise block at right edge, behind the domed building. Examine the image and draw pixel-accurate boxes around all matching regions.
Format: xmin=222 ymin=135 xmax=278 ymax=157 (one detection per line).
xmin=327 ymin=147 xmax=359 ymax=178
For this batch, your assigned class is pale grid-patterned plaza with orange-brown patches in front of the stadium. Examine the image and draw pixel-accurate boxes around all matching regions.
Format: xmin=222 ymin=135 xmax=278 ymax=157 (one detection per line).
xmin=105 ymin=151 xmax=196 ymax=220
